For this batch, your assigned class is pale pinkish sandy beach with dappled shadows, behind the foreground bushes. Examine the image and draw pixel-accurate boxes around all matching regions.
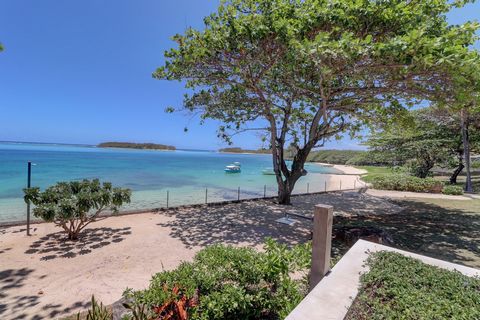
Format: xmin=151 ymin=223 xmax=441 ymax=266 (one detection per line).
xmin=0 ymin=167 xmax=366 ymax=319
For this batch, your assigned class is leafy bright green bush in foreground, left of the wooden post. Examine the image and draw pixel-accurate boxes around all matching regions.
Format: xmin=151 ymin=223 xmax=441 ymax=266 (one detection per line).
xmin=124 ymin=240 xmax=311 ymax=320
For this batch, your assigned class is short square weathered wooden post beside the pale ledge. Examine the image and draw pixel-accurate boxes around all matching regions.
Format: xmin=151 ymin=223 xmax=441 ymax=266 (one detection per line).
xmin=310 ymin=204 xmax=333 ymax=291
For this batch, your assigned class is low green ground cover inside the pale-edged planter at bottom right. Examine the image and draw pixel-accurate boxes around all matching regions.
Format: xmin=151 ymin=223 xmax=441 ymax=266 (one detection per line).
xmin=345 ymin=251 xmax=480 ymax=320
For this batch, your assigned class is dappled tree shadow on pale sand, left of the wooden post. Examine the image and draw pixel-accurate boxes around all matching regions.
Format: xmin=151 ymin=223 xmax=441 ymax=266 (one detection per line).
xmin=158 ymin=200 xmax=310 ymax=248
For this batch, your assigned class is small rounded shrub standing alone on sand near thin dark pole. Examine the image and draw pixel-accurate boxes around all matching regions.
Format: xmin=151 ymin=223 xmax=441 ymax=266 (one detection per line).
xmin=23 ymin=179 xmax=131 ymax=240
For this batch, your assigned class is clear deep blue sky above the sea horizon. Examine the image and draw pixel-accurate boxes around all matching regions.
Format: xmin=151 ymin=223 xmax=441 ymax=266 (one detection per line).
xmin=0 ymin=0 xmax=480 ymax=149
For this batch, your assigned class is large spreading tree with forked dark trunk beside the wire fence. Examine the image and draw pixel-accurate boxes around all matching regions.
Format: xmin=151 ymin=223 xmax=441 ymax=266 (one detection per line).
xmin=154 ymin=0 xmax=478 ymax=204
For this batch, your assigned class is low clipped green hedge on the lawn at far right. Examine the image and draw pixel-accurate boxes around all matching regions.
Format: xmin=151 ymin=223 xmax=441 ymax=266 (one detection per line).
xmin=371 ymin=174 xmax=443 ymax=193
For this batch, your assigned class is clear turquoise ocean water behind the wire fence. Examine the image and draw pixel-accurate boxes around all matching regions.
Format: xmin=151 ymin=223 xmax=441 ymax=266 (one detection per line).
xmin=0 ymin=143 xmax=339 ymax=222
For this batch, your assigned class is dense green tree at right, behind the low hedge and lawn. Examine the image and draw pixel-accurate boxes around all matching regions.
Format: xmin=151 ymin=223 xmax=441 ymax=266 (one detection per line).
xmin=366 ymin=107 xmax=480 ymax=178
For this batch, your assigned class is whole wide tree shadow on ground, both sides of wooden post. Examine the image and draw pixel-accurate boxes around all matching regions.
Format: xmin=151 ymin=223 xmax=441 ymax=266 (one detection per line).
xmin=158 ymin=192 xmax=480 ymax=268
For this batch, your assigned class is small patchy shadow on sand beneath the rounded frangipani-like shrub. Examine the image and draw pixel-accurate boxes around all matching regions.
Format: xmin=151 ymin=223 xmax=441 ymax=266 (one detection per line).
xmin=25 ymin=227 xmax=132 ymax=260
